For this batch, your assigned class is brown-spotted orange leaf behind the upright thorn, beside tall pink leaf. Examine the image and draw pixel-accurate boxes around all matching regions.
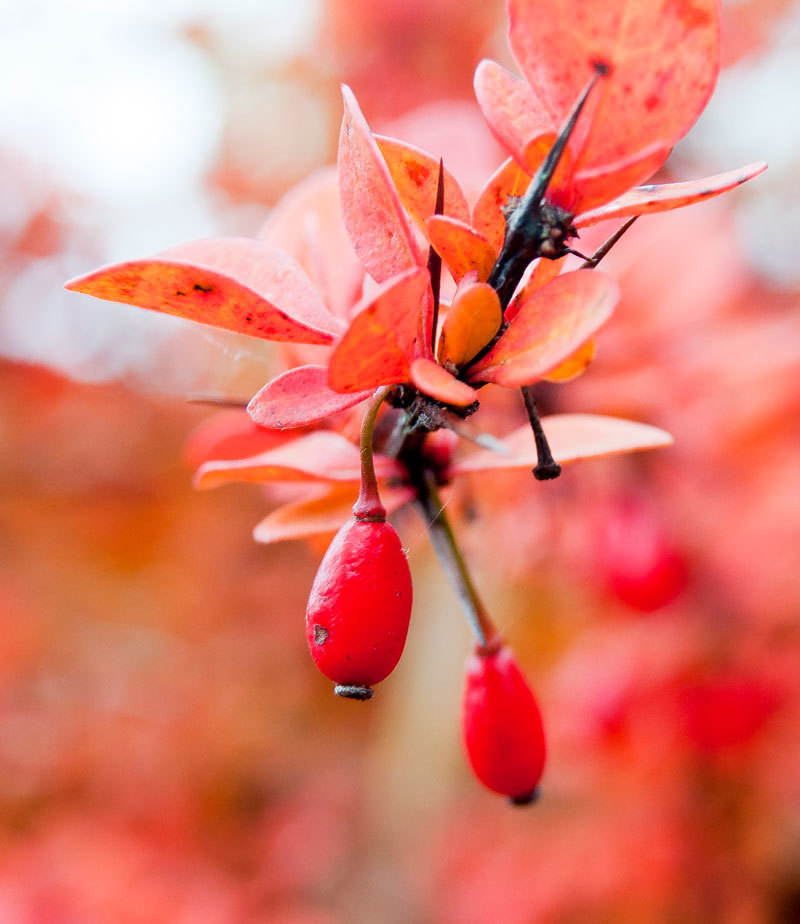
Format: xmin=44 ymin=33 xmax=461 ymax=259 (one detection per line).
xmin=374 ymin=135 xmax=469 ymax=234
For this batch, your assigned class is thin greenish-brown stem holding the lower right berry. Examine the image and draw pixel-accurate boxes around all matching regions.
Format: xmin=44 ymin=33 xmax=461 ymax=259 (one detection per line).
xmin=417 ymin=472 xmax=498 ymax=650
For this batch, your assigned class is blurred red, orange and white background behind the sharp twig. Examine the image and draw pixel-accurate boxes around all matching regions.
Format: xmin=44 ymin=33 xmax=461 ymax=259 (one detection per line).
xmin=0 ymin=0 xmax=800 ymax=924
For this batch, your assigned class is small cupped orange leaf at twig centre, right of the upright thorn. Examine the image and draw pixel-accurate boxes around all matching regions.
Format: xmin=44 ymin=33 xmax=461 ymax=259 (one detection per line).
xmin=438 ymin=282 xmax=503 ymax=366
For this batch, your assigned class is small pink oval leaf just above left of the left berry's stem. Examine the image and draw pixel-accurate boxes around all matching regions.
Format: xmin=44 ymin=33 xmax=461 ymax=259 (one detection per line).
xmin=247 ymin=366 xmax=372 ymax=430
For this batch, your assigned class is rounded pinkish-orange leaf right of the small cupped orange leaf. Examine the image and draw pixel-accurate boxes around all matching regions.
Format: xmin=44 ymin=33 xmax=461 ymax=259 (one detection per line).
xmin=469 ymin=270 xmax=619 ymax=388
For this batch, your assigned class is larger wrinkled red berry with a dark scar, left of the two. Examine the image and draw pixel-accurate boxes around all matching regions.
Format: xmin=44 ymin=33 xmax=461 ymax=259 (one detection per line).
xmin=306 ymin=519 xmax=412 ymax=699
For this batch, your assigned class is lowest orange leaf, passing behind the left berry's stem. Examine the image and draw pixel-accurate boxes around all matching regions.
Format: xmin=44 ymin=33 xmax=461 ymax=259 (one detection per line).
xmin=253 ymin=485 xmax=414 ymax=543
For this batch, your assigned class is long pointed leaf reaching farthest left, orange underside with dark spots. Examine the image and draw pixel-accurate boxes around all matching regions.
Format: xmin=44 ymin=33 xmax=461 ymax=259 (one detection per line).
xmin=66 ymin=237 xmax=342 ymax=343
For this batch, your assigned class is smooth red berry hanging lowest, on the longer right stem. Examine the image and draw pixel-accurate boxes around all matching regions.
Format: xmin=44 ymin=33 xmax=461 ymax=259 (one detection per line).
xmin=463 ymin=644 xmax=546 ymax=805
